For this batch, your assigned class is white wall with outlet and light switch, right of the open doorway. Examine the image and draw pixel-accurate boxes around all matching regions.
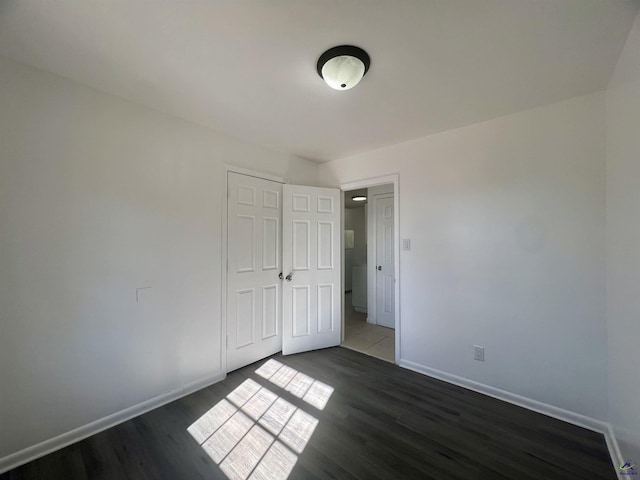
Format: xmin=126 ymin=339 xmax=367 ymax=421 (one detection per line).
xmin=320 ymin=93 xmax=607 ymax=419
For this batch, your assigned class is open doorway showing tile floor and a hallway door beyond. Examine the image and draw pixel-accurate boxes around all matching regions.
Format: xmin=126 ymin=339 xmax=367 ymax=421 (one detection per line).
xmin=342 ymin=183 xmax=398 ymax=363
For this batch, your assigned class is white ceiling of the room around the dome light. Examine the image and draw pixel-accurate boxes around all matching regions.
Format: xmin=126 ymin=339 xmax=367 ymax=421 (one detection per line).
xmin=0 ymin=0 xmax=639 ymax=161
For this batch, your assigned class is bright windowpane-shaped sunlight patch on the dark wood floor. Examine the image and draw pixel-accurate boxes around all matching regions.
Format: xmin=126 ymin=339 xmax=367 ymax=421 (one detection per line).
xmin=187 ymin=360 xmax=334 ymax=480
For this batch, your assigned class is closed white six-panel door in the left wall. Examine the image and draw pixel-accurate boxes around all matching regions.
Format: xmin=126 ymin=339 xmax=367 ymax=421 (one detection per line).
xmin=227 ymin=172 xmax=282 ymax=372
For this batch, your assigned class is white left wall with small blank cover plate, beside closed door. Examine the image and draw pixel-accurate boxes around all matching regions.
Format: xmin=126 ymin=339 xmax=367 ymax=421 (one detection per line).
xmin=0 ymin=54 xmax=317 ymax=463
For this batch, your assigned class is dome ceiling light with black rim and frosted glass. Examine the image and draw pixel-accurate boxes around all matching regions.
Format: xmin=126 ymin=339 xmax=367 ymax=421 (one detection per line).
xmin=317 ymin=45 xmax=371 ymax=90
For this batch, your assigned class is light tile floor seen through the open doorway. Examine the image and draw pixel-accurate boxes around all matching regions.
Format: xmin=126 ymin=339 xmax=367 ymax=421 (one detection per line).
xmin=342 ymin=293 xmax=396 ymax=363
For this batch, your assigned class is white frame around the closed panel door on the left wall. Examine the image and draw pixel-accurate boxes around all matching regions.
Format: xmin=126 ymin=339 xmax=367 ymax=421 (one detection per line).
xmin=220 ymin=165 xmax=289 ymax=377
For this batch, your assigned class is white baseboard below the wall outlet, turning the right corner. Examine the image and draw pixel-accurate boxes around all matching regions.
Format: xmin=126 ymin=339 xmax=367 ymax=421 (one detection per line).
xmin=398 ymin=359 xmax=628 ymax=472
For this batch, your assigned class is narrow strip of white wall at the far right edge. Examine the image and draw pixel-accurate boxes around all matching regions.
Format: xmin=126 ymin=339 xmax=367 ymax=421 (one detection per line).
xmin=607 ymin=12 xmax=640 ymax=464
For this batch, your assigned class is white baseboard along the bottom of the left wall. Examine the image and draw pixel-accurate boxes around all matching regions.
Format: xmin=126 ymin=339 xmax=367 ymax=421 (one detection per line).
xmin=0 ymin=373 xmax=226 ymax=474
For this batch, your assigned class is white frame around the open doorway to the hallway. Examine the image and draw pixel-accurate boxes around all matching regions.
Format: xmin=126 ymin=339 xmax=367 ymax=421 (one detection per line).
xmin=340 ymin=173 xmax=402 ymax=365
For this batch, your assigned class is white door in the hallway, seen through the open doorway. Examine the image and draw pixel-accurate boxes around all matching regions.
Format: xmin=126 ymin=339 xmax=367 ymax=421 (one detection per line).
xmin=375 ymin=195 xmax=396 ymax=328
